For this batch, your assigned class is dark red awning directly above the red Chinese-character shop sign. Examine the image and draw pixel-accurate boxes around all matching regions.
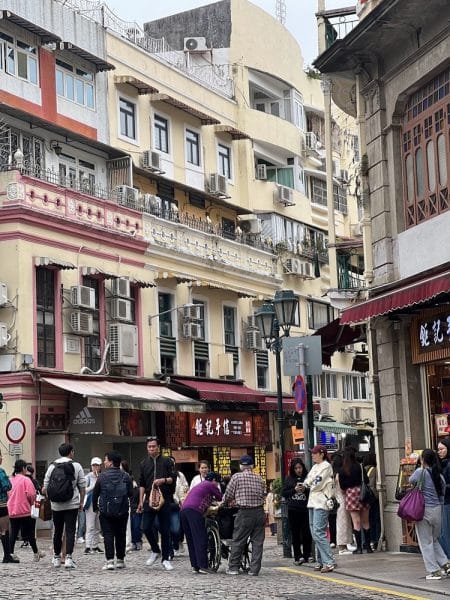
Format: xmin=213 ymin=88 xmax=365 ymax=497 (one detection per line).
xmin=171 ymin=377 xmax=265 ymax=402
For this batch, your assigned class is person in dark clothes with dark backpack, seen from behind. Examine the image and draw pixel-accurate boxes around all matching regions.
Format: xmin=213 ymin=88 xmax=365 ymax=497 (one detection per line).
xmin=92 ymin=450 xmax=133 ymax=571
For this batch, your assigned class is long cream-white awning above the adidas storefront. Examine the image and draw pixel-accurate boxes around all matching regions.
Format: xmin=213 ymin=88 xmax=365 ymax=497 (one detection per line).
xmin=41 ymin=376 xmax=204 ymax=412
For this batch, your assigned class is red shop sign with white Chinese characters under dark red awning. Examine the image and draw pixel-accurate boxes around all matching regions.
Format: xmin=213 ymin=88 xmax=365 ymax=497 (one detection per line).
xmin=189 ymin=412 xmax=253 ymax=446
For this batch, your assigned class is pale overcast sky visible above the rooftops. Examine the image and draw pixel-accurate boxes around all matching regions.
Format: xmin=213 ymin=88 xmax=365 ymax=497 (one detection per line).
xmin=105 ymin=0 xmax=356 ymax=65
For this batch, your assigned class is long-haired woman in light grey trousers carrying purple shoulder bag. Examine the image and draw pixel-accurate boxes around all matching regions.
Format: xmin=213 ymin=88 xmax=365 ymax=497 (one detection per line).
xmin=409 ymin=448 xmax=450 ymax=579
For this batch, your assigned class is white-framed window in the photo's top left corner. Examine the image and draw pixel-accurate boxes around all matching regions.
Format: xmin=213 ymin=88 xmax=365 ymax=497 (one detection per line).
xmin=0 ymin=32 xmax=38 ymax=85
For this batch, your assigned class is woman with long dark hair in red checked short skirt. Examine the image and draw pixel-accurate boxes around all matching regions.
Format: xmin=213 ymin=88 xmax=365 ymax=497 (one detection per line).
xmin=339 ymin=446 xmax=373 ymax=554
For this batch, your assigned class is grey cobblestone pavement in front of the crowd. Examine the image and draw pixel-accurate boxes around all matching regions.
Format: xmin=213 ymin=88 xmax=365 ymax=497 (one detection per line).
xmin=0 ymin=539 xmax=414 ymax=600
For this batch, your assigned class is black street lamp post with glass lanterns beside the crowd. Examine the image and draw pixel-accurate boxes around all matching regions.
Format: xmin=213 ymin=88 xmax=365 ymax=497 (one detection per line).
xmin=255 ymin=290 xmax=298 ymax=558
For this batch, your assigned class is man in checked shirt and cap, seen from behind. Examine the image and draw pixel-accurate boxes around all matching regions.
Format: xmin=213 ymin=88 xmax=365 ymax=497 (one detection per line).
xmin=223 ymin=454 xmax=266 ymax=576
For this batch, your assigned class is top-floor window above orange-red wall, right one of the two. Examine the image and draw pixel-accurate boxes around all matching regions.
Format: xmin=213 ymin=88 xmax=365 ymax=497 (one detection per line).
xmin=56 ymin=58 xmax=95 ymax=108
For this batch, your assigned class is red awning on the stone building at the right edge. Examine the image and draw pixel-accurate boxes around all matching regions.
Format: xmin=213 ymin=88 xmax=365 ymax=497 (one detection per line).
xmin=341 ymin=271 xmax=450 ymax=324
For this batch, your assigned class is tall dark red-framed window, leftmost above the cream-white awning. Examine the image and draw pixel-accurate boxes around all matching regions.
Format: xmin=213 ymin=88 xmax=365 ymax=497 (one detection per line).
xmin=36 ymin=267 xmax=56 ymax=368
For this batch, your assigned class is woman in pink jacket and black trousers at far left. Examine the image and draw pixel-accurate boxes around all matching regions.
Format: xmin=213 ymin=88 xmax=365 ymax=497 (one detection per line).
xmin=8 ymin=460 xmax=45 ymax=562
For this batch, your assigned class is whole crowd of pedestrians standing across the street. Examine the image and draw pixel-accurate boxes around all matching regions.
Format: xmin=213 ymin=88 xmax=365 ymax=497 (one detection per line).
xmin=0 ymin=437 xmax=450 ymax=579
